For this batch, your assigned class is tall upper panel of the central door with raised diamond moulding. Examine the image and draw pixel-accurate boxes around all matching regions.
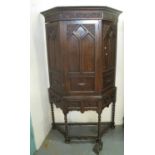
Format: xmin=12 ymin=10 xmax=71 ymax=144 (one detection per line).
xmin=67 ymin=24 xmax=95 ymax=73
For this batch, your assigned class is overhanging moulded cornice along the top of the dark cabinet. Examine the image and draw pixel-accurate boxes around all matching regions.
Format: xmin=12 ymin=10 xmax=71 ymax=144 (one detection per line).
xmin=41 ymin=6 xmax=121 ymax=23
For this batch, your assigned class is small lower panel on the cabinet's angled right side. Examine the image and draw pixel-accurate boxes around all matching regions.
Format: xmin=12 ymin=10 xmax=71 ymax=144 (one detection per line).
xmin=103 ymin=71 xmax=115 ymax=89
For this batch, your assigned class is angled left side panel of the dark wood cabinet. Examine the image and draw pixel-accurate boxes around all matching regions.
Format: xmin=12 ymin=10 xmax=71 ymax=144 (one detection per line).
xmin=46 ymin=22 xmax=63 ymax=92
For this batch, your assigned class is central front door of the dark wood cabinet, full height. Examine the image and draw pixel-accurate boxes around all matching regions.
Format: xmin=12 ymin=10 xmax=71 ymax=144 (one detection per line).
xmin=62 ymin=20 xmax=102 ymax=94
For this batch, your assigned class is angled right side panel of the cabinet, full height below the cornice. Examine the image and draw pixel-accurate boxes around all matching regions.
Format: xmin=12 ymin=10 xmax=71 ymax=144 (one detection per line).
xmin=102 ymin=21 xmax=116 ymax=89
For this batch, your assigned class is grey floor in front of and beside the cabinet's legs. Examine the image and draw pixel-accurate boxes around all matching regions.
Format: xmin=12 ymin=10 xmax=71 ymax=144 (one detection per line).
xmin=35 ymin=126 xmax=124 ymax=155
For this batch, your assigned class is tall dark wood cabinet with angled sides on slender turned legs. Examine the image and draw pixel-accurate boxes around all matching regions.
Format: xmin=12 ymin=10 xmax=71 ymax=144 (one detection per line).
xmin=42 ymin=7 xmax=121 ymax=153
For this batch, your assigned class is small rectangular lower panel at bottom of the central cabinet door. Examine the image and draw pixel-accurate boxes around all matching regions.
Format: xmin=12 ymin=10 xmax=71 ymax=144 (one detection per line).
xmin=70 ymin=77 xmax=95 ymax=91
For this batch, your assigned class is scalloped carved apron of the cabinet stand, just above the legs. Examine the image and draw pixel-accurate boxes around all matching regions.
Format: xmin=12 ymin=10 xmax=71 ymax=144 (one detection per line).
xmin=51 ymin=89 xmax=116 ymax=113
